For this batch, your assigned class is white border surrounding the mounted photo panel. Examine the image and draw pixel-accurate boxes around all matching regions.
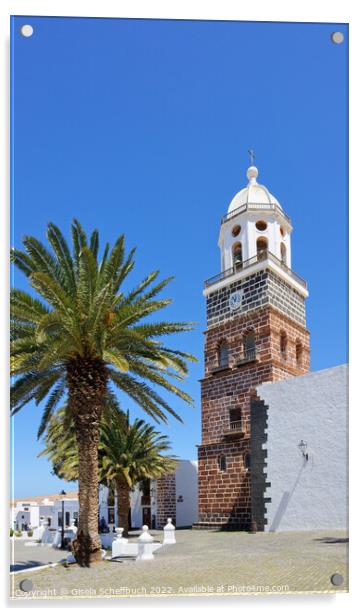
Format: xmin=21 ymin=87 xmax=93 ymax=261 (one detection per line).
xmin=0 ymin=0 xmax=364 ymax=614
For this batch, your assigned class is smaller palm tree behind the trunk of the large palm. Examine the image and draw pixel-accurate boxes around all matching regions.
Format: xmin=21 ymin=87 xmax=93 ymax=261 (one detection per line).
xmin=40 ymin=407 xmax=178 ymax=533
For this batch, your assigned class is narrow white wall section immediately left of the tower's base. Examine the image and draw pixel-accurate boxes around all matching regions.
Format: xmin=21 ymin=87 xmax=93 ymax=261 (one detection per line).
xmin=175 ymin=460 xmax=198 ymax=527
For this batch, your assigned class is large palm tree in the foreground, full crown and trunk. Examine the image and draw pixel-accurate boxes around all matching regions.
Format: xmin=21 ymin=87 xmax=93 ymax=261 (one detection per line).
xmin=11 ymin=220 xmax=194 ymax=566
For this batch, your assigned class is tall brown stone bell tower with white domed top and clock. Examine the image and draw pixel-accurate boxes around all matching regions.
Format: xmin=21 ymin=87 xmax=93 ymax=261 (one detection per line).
xmin=198 ymin=159 xmax=310 ymax=529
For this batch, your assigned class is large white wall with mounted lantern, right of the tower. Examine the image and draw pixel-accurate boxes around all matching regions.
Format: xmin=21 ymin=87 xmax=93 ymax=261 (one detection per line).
xmin=257 ymin=365 xmax=348 ymax=531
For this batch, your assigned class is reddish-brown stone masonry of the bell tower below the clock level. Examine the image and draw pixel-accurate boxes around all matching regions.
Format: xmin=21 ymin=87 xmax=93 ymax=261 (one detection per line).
xmin=199 ymin=306 xmax=309 ymax=528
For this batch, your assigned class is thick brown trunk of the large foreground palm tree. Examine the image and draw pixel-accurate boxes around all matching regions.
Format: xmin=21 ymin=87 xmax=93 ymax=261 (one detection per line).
xmin=67 ymin=358 xmax=107 ymax=567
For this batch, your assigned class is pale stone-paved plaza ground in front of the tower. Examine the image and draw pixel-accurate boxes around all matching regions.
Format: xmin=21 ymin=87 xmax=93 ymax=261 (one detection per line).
xmin=11 ymin=530 xmax=348 ymax=599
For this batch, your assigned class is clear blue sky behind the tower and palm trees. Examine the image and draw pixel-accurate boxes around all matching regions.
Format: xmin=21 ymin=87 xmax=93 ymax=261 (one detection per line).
xmin=12 ymin=17 xmax=348 ymax=497
